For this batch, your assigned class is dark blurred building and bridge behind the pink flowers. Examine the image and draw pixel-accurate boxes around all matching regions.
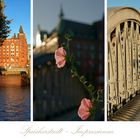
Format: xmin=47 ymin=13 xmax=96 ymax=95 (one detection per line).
xmin=33 ymin=0 xmax=104 ymax=120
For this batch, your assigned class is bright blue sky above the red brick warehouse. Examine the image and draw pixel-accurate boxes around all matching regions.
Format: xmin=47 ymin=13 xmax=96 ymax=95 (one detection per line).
xmin=4 ymin=0 xmax=30 ymax=44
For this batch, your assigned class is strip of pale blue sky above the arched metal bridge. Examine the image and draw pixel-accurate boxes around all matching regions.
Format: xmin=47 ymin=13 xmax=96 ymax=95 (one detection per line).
xmin=107 ymin=0 xmax=140 ymax=11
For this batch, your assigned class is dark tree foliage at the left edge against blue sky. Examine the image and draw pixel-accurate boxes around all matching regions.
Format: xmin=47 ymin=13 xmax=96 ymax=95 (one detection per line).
xmin=0 ymin=0 xmax=11 ymax=46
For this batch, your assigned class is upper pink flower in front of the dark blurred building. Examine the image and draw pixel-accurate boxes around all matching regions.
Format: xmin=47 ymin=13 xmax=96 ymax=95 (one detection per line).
xmin=55 ymin=47 xmax=66 ymax=68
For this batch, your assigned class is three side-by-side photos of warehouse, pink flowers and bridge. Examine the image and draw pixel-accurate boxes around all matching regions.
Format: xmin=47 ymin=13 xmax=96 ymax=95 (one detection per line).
xmin=0 ymin=0 xmax=140 ymax=121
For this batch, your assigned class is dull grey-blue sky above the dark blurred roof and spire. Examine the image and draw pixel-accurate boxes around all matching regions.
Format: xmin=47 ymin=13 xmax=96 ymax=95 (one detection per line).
xmin=33 ymin=0 xmax=104 ymax=40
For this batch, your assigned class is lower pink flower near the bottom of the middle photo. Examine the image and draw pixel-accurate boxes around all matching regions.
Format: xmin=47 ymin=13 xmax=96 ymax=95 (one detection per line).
xmin=78 ymin=98 xmax=92 ymax=120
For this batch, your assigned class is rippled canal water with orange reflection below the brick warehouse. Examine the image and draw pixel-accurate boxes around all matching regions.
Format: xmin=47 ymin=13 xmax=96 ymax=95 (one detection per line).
xmin=0 ymin=75 xmax=30 ymax=121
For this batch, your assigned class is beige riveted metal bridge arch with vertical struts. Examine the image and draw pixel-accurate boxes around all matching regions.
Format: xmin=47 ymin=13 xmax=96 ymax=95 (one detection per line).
xmin=107 ymin=7 xmax=140 ymax=120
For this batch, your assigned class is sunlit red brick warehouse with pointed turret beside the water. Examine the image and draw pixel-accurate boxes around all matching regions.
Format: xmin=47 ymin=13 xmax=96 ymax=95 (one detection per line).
xmin=0 ymin=26 xmax=28 ymax=69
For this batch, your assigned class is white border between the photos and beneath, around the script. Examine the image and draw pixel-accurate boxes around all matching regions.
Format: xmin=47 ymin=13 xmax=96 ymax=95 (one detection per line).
xmin=0 ymin=0 xmax=140 ymax=140
